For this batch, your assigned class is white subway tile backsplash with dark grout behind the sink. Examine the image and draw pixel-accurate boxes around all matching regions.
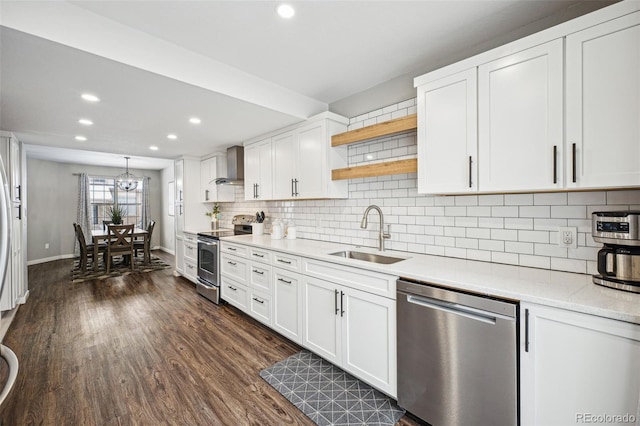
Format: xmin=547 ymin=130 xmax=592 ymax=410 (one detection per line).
xmin=222 ymin=99 xmax=640 ymax=274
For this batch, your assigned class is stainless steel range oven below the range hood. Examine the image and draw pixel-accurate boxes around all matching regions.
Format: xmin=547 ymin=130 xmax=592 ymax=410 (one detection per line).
xmin=196 ymin=215 xmax=255 ymax=304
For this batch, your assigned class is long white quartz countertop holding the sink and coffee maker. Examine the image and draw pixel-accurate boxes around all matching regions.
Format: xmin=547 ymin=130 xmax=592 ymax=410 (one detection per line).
xmin=222 ymin=235 xmax=640 ymax=324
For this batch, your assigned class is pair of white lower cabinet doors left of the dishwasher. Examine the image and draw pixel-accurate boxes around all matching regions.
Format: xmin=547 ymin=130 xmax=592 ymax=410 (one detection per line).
xmin=302 ymin=276 xmax=397 ymax=398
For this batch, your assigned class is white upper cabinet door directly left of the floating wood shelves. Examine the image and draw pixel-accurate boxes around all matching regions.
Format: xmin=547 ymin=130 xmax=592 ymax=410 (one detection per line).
xmin=294 ymin=121 xmax=324 ymax=198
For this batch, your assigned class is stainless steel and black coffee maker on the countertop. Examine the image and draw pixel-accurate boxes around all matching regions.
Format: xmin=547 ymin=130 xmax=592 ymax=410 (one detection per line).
xmin=591 ymin=211 xmax=640 ymax=293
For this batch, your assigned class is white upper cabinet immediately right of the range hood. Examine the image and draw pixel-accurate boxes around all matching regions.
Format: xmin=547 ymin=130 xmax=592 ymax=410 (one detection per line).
xmin=244 ymin=138 xmax=273 ymax=200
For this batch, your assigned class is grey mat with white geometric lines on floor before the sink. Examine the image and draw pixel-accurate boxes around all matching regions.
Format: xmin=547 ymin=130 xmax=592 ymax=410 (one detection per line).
xmin=260 ymin=350 xmax=405 ymax=426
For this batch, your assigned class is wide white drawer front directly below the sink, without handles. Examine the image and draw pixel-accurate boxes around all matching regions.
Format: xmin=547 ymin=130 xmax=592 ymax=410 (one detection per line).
xmin=302 ymin=259 xmax=397 ymax=300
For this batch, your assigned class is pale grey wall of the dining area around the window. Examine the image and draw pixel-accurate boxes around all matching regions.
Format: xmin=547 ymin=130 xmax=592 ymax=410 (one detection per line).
xmin=27 ymin=158 xmax=163 ymax=264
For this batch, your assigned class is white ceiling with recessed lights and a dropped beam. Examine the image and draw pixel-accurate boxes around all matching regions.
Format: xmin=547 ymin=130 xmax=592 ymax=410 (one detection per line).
xmin=0 ymin=0 xmax=608 ymax=168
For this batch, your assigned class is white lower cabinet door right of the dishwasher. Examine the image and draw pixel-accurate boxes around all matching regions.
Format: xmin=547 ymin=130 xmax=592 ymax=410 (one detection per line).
xmin=520 ymin=303 xmax=640 ymax=425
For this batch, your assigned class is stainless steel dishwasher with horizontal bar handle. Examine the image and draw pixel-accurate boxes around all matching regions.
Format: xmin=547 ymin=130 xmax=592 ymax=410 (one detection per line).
xmin=397 ymin=279 xmax=518 ymax=426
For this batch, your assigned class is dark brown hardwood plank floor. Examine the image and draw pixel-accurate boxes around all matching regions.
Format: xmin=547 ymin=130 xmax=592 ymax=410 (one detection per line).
xmin=0 ymin=252 xmax=424 ymax=426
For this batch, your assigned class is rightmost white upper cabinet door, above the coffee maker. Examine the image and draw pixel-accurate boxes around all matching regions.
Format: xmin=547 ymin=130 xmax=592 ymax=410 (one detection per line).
xmin=566 ymin=12 xmax=640 ymax=188
